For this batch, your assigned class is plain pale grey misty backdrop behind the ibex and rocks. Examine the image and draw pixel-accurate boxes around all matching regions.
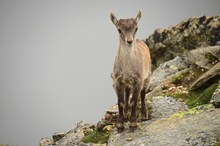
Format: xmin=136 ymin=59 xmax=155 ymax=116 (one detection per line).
xmin=0 ymin=0 xmax=220 ymax=146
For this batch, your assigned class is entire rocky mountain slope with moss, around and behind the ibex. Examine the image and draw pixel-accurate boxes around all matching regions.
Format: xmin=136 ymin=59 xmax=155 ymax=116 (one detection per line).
xmin=39 ymin=15 xmax=220 ymax=146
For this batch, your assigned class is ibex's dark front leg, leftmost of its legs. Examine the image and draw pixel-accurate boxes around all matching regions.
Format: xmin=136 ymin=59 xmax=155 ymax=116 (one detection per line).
xmin=115 ymin=84 xmax=125 ymax=133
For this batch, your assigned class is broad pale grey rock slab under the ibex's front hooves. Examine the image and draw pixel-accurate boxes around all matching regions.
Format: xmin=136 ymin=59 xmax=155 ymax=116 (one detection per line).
xmin=108 ymin=105 xmax=220 ymax=146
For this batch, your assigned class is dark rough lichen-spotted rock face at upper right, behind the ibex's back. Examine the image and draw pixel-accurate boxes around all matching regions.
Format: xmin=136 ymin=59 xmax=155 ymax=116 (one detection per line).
xmin=145 ymin=15 xmax=220 ymax=69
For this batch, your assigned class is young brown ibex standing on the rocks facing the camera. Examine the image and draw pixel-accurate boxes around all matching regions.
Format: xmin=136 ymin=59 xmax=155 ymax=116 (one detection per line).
xmin=110 ymin=10 xmax=151 ymax=132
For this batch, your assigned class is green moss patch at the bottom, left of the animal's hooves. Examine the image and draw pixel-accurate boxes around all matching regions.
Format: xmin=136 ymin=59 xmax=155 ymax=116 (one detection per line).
xmin=81 ymin=129 xmax=111 ymax=144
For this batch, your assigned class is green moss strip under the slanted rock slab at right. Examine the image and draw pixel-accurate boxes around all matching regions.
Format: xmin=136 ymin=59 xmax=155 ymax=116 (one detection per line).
xmin=188 ymin=83 xmax=218 ymax=108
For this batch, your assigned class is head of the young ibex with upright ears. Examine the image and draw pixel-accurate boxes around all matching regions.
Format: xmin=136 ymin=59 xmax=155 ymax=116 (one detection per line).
xmin=110 ymin=10 xmax=142 ymax=46
